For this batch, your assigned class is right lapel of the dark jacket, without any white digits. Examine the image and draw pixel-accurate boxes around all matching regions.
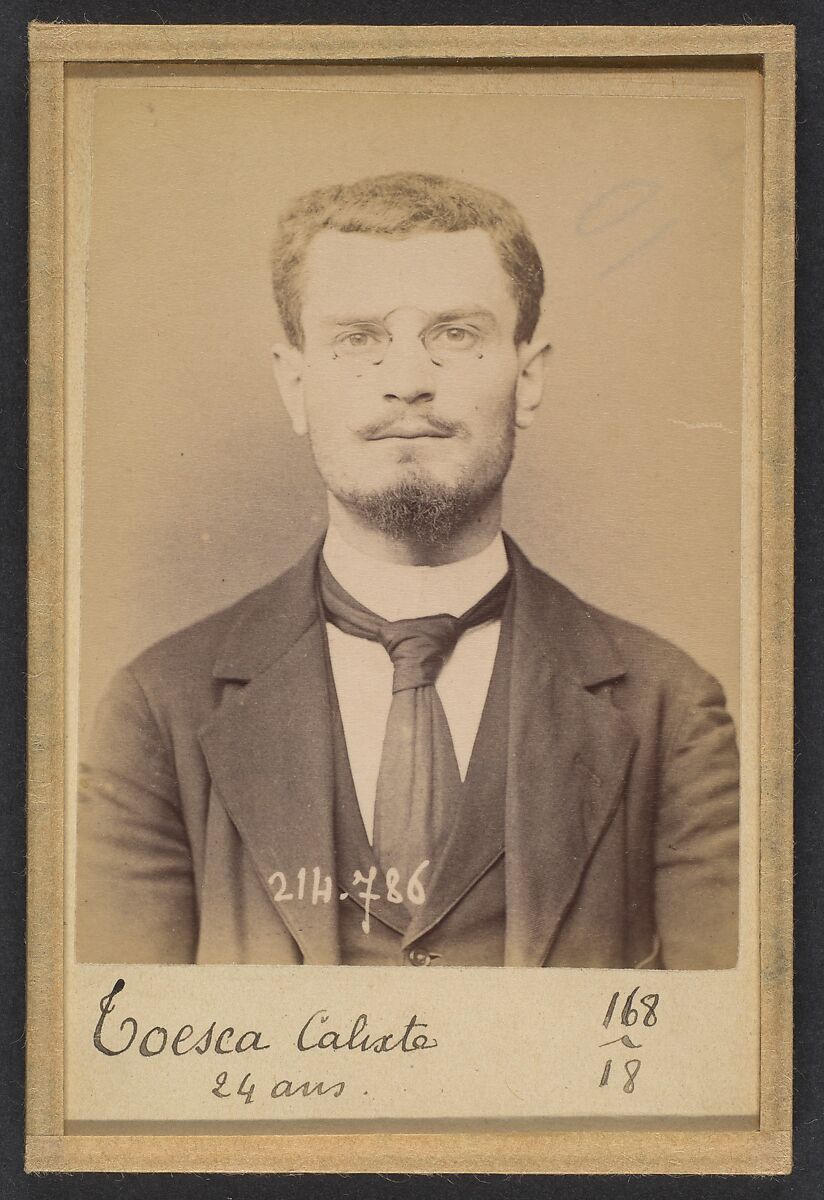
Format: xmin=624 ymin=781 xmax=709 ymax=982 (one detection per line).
xmin=505 ymin=539 xmax=637 ymax=966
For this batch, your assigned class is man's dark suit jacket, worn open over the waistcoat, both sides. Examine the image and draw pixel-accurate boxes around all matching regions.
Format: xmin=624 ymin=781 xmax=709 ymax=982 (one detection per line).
xmin=77 ymin=541 xmax=738 ymax=968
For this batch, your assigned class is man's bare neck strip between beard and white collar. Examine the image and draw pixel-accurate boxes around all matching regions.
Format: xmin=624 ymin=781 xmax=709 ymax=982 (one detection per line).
xmin=327 ymin=493 xmax=501 ymax=566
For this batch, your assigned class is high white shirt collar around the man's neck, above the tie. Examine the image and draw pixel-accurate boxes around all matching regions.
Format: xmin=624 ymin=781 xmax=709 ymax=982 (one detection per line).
xmin=323 ymin=526 xmax=509 ymax=620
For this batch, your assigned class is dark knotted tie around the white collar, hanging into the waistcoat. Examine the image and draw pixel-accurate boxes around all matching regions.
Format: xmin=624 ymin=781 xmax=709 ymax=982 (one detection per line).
xmin=320 ymin=558 xmax=510 ymax=893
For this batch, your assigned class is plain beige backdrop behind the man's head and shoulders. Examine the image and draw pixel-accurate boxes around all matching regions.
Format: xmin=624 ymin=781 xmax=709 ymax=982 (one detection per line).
xmin=70 ymin=67 xmax=745 ymax=744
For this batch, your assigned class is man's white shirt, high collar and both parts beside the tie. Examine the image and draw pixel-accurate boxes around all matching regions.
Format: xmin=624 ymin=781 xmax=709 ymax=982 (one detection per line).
xmin=323 ymin=526 xmax=509 ymax=841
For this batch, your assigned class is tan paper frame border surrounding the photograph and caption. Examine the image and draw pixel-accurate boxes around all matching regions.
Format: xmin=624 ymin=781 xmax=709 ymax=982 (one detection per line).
xmin=26 ymin=23 xmax=794 ymax=1175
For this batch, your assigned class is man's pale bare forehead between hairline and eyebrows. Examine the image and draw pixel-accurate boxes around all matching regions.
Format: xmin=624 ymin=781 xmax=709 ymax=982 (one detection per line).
xmin=303 ymin=229 xmax=513 ymax=316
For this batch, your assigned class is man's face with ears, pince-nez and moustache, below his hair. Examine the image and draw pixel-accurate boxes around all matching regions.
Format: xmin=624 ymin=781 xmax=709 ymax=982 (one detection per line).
xmin=276 ymin=229 xmax=546 ymax=544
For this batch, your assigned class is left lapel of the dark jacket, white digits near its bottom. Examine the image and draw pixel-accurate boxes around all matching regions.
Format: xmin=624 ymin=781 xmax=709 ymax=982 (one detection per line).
xmin=200 ymin=544 xmax=339 ymax=964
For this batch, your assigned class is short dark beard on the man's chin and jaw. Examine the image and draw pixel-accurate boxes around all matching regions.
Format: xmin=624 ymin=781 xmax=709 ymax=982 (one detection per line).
xmin=335 ymin=437 xmax=513 ymax=547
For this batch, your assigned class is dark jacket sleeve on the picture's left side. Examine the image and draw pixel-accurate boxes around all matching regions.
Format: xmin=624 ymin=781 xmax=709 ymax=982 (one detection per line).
xmin=76 ymin=668 xmax=197 ymax=962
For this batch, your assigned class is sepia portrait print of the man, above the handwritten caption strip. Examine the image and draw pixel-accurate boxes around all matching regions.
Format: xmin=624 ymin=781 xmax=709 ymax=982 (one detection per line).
xmin=74 ymin=68 xmax=744 ymax=970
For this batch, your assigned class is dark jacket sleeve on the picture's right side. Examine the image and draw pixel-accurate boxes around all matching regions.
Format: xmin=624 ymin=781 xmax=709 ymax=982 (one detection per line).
xmin=655 ymin=666 xmax=739 ymax=970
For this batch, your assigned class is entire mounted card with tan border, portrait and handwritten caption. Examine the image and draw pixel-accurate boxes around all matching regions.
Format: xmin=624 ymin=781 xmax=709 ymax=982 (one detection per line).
xmin=28 ymin=25 xmax=793 ymax=1174
